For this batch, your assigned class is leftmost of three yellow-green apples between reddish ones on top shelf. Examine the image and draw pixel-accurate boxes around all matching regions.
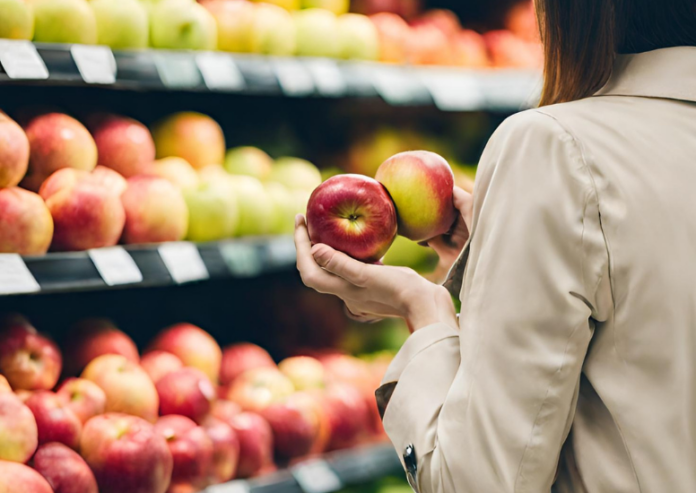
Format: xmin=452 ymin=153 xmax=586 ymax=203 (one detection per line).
xmin=250 ymin=3 xmax=297 ymax=56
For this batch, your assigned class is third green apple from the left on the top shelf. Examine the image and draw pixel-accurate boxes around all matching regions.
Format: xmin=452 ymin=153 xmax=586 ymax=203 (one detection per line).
xmin=90 ymin=0 xmax=150 ymax=49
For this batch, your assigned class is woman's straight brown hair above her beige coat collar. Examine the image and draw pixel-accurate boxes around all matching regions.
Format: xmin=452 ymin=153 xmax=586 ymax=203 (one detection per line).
xmin=535 ymin=0 xmax=696 ymax=106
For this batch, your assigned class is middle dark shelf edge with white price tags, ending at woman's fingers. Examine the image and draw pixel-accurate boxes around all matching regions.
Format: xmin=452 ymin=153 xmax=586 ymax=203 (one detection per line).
xmin=0 ymin=236 xmax=296 ymax=295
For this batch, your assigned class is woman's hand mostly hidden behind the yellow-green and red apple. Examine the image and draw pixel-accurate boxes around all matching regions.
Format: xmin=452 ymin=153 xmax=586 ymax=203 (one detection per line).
xmin=427 ymin=187 xmax=474 ymax=283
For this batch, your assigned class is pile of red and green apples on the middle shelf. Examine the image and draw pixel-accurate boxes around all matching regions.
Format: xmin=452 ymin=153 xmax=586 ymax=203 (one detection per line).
xmin=0 ymin=112 xmax=321 ymax=255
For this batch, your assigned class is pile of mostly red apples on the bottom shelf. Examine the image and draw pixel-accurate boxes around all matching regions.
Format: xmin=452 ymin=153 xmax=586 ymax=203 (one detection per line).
xmin=0 ymin=315 xmax=389 ymax=493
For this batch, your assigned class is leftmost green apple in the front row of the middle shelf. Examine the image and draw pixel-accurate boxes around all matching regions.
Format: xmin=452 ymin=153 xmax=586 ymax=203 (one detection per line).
xmin=184 ymin=182 xmax=239 ymax=241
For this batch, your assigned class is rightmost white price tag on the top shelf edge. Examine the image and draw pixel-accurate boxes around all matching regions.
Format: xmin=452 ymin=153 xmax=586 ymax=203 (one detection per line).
xmin=422 ymin=69 xmax=485 ymax=111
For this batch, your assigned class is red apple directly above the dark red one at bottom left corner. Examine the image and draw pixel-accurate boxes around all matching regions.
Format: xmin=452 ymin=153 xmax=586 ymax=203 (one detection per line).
xmin=25 ymin=390 xmax=82 ymax=450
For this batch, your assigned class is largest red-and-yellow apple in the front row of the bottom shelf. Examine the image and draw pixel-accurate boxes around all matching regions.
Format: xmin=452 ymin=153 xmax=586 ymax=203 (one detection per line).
xmin=80 ymin=413 xmax=173 ymax=493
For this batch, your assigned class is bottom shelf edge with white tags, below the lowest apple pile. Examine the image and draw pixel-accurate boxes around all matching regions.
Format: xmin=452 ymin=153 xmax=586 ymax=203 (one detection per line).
xmin=203 ymin=444 xmax=403 ymax=493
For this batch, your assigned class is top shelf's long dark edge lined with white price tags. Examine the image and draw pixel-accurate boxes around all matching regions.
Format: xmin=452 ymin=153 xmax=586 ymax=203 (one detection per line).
xmin=0 ymin=40 xmax=541 ymax=111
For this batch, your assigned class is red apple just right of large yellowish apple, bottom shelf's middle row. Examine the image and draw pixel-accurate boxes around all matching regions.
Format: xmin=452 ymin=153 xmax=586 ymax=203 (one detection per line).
xmin=156 ymin=368 xmax=215 ymax=422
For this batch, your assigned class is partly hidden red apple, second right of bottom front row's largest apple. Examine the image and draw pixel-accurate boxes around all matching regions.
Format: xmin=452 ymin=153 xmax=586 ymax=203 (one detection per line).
xmin=201 ymin=415 xmax=240 ymax=484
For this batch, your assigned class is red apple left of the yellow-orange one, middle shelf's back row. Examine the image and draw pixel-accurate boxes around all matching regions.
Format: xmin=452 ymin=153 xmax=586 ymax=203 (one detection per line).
xmin=89 ymin=115 xmax=155 ymax=178
